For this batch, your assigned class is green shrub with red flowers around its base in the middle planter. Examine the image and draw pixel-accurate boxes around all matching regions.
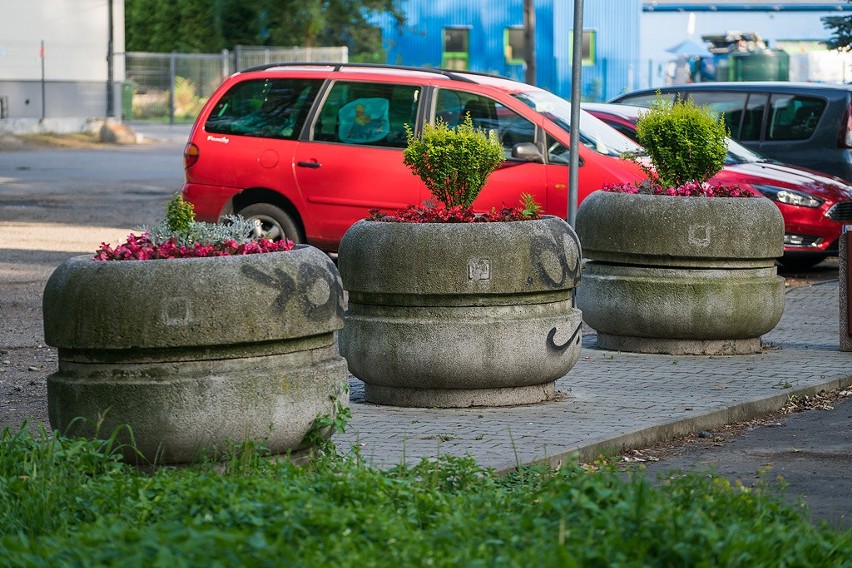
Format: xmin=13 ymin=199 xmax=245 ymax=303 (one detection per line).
xmin=368 ymin=115 xmax=541 ymax=223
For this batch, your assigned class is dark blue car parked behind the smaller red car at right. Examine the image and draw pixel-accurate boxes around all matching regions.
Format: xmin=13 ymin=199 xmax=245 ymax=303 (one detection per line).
xmin=609 ymin=81 xmax=852 ymax=182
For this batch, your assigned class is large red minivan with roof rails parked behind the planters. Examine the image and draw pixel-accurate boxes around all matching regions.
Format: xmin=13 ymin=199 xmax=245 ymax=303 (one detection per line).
xmin=183 ymin=64 xmax=644 ymax=252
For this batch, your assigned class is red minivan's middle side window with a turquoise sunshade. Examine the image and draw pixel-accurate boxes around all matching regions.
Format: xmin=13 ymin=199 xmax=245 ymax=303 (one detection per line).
xmin=311 ymin=81 xmax=421 ymax=148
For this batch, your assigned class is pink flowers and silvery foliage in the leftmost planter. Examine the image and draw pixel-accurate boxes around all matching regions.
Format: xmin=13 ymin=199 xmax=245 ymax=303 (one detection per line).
xmin=93 ymin=194 xmax=295 ymax=261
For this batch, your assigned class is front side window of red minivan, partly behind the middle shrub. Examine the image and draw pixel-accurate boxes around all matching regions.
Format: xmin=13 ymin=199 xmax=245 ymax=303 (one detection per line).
xmin=435 ymin=89 xmax=535 ymax=160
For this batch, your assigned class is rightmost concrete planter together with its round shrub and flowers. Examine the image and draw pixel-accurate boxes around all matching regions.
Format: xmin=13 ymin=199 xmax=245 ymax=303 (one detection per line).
xmin=576 ymin=97 xmax=784 ymax=355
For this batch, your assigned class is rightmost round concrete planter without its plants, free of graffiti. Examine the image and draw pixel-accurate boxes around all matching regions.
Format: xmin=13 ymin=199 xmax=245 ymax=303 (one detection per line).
xmin=577 ymin=191 xmax=784 ymax=354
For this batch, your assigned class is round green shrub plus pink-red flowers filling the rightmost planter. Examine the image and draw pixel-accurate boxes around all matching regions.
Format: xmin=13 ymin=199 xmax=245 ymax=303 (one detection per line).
xmin=602 ymin=97 xmax=757 ymax=197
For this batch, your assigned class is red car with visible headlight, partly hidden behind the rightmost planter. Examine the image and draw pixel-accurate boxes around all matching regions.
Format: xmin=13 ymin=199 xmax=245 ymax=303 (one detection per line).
xmin=583 ymin=103 xmax=852 ymax=268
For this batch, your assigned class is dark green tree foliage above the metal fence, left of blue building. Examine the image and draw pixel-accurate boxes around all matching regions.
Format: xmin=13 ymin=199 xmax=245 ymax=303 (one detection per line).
xmin=125 ymin=0 xmax=404 ymax=58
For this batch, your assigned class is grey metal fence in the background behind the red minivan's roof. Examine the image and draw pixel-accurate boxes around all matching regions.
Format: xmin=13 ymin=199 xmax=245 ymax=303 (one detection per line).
xmin=121 ymin=45 xmax=349 ymax=123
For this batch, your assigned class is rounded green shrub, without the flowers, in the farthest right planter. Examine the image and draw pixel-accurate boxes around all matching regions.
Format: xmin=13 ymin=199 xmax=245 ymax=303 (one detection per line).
xmin=636 ymin=97 xmax=728 ymax=187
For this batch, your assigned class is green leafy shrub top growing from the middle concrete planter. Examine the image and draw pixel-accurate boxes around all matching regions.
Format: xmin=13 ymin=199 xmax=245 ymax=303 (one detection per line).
xmin=402 ymin=115 xmax=503 ymax=208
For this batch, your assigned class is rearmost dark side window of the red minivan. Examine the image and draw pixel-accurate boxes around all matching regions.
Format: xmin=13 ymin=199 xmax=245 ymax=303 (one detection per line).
xmin=204 ymin=79 xmax=322 ymax=140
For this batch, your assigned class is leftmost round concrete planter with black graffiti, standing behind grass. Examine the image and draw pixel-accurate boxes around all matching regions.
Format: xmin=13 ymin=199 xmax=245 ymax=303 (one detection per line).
xmin=44 ymin=246 xmax=348 ymax=463
